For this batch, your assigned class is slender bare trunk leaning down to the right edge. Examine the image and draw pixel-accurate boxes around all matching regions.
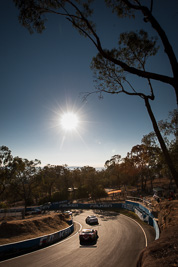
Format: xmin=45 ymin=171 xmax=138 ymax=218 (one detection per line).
xmin=144 ymin=97 xmax=178 ymax=188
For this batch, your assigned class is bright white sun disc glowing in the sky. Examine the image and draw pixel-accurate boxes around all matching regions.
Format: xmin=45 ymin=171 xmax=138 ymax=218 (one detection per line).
xmin=60 ymin=112 xmax=79 ymax=131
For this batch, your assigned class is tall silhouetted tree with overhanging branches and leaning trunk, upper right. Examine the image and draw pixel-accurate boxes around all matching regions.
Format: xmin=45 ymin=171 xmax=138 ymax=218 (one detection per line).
xmin=14 ymin=0 xmax=178 ymax=187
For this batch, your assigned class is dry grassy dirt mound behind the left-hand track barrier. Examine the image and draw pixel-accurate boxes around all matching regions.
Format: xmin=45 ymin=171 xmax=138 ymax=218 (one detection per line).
xmin=0 ymin=214 xmax=69 ymax=245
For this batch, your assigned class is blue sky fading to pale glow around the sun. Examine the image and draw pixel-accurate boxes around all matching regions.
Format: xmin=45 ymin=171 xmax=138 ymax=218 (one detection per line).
xmin=0 ymin=0 xmax=178 ymax=168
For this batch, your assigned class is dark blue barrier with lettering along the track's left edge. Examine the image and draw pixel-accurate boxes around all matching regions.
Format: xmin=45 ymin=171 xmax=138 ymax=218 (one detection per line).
xmin=0 ymin=224 xmax=74 ymax=259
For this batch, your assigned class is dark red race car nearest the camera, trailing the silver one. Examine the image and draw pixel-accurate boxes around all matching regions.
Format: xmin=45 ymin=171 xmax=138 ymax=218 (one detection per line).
xmin=79 ymin=229 xmax=98 ymax=245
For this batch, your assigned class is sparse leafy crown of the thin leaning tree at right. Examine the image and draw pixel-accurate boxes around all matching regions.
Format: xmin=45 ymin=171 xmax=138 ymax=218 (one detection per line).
xmin=91 ymin=30 xmax=158 ymax=100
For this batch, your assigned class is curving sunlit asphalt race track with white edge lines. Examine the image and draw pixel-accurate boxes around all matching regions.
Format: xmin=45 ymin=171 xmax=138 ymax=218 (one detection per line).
xmin=0 ymin=210 xmax=154 ymax=267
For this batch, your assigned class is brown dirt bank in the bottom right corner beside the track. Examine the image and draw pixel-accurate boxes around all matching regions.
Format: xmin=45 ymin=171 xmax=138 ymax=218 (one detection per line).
xmin=137 ymin=200 xmax=178 ymax=267
